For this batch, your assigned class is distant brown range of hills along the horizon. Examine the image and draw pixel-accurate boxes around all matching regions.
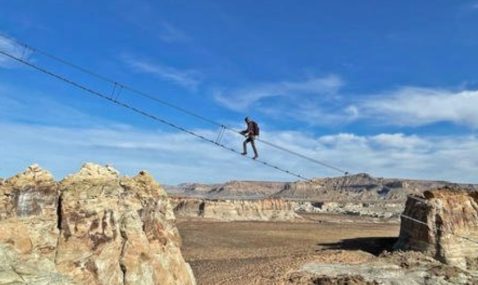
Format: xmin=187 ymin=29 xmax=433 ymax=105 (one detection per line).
xmin=165 ymin=173 xmax=478 ymax=203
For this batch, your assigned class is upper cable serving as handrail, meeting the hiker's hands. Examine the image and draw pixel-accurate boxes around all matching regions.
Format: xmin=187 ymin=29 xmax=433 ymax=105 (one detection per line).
xmin=0 ymin=33 xmax=349 ymax=176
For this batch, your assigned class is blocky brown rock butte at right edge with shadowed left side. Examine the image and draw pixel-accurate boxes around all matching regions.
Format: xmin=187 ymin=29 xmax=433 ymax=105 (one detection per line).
xmin=395 ymin=188 xmax=478 ymax=270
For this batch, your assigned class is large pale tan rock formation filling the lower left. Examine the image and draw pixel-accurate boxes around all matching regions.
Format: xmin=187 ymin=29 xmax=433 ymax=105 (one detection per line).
xmin=0 ymin=164 xmax=195 ymax=285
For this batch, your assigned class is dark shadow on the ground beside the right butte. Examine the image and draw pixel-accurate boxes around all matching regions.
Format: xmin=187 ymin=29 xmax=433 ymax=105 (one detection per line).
xmin=317 ymin=237 xmax=398 ymax=255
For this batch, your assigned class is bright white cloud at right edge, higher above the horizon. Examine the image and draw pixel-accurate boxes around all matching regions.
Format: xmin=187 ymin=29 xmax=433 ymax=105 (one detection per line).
xmin=359 ymin=87 xmax=478 ymax=129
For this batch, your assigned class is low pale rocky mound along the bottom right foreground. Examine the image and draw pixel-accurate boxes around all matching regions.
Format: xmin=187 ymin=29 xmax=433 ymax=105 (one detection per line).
xmin=296 ymin=251 xmax=478 ymax=285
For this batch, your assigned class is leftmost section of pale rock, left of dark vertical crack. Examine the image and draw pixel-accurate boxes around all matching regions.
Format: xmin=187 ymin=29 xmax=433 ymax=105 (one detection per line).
xmin=0 ymin=165 xmax=75 ymax=285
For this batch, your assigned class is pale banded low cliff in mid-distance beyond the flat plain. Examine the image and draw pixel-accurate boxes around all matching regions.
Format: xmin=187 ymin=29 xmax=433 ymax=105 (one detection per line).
xmin=172 ymin=197 xmax=300 ymax=221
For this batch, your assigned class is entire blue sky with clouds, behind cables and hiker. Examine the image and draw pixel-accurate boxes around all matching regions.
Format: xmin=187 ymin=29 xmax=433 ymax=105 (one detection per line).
xmin=0 ymin=0 xmax=478 ymax=184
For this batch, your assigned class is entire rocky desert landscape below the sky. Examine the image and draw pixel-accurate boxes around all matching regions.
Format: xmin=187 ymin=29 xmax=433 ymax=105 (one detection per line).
xmin=0 ymin=164 xmax=478 ymax=285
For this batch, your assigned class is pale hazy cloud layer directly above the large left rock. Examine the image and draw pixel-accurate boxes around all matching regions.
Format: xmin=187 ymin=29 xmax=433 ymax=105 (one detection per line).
xmin=0 ymin=123 xmax=272 ymax=184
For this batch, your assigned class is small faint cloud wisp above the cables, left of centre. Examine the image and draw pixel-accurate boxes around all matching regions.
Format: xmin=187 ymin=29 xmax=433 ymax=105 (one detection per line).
xmin=122 ymin=55 xmax=201 ymax=91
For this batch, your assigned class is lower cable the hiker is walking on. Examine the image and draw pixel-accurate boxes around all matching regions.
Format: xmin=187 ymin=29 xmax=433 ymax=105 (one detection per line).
xmin=0 ymin=47 xmax=312 ymax=181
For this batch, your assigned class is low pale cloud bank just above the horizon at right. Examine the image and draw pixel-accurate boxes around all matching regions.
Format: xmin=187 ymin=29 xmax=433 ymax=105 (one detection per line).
xmin=310 ymin=131 xmax=478 ymax=182
